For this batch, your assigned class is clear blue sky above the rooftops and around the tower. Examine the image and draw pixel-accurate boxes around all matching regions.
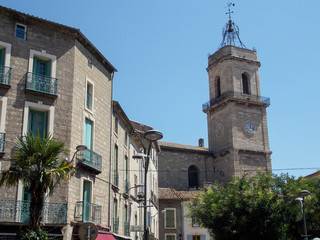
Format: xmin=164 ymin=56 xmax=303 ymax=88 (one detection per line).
xmin=0 ymin=0 xmax=320 ymax=176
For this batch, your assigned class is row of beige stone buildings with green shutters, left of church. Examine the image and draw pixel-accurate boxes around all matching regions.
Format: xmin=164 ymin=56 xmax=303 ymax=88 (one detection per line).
xmin=0 ymin=6 xmax=160 ymax=239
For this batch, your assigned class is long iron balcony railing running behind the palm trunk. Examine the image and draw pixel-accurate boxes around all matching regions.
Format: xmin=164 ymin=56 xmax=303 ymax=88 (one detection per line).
xmin=0 ymin=199 xmax=68 ymax=224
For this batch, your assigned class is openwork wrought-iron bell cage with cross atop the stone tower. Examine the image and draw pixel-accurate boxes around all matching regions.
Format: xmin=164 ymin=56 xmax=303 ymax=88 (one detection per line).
xmin=219 ymin=1 xmax=245 ymax=49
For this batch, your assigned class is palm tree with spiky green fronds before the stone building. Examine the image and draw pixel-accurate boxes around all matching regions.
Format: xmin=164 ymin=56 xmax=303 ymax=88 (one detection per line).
xmin=0 ymin=133 xmax=73 ymax=232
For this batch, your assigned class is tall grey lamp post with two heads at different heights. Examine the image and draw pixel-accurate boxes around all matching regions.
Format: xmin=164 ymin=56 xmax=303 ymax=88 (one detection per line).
xmin=133 ymin=130 xmax=163 ymax=240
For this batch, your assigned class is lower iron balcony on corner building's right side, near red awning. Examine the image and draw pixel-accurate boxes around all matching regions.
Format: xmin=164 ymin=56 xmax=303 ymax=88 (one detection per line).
xmin=74 ymin=201 xmax=102 ymax=224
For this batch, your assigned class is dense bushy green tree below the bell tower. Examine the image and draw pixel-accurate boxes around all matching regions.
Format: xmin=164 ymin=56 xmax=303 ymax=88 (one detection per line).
xmin=189 ymin=172 xmax=320 ymax=240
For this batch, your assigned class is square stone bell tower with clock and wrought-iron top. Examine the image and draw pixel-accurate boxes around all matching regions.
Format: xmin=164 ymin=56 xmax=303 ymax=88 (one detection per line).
xmin=203 ymin=3 xmax=271 ymax=179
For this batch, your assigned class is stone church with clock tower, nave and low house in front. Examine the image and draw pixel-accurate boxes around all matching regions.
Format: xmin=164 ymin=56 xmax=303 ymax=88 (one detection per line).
xmin=159 ymin=6 xmax=271 ymax=240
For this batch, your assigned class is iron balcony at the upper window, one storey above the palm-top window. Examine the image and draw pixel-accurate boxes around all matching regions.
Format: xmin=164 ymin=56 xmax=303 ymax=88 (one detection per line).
xmin=25 ymin=72 xmax=58 ymax=96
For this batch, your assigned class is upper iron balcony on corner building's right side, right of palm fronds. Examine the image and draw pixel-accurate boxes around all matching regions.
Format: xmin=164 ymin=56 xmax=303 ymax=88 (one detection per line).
xmin=77 ymin=149 xmax=102 ymax=174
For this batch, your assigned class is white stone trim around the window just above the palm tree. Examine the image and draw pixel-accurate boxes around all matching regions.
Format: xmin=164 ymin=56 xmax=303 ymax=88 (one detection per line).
xmin=22 ymin=101 xmax=54 ymax=136
